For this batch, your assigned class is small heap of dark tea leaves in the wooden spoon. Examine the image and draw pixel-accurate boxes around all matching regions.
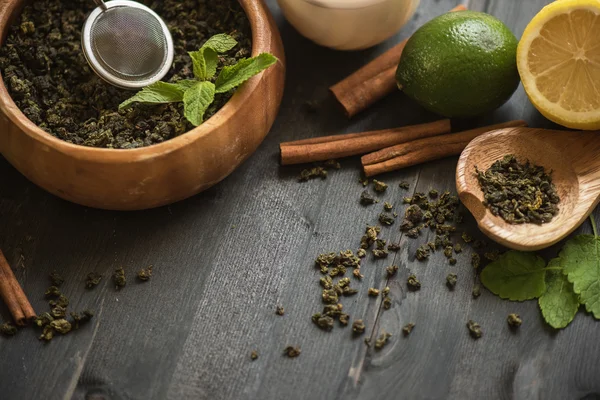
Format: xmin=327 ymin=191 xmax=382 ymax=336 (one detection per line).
xmin=475 ymin=154 xmax=560 ymax=224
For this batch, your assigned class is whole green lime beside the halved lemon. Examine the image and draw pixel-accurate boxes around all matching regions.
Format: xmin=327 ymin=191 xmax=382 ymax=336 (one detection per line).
xmin=396 ymin=11 xmax=519 ymax=117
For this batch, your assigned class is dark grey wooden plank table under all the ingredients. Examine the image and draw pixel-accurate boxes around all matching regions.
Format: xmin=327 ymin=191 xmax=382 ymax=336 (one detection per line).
xmin=0 ymin=0 xmax=600 ymax=400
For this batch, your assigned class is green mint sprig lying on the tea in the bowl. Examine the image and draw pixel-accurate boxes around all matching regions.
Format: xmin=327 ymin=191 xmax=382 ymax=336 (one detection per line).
xmin=119 ymin=34 xmax=277 ymax=126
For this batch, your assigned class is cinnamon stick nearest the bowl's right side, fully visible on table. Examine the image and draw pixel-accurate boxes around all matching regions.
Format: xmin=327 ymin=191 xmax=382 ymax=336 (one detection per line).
xmin=280 ymin=119 xmax=450 ymax=165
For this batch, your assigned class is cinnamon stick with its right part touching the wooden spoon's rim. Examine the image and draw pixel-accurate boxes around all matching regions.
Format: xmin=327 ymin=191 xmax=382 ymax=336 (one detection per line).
xmin=361 ymin=120 xmax=527 ymax=177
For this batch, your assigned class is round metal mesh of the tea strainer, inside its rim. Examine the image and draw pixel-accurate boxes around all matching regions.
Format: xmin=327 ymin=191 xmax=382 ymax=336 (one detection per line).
xmin=90 ymin=7 xmax=167 ymax=80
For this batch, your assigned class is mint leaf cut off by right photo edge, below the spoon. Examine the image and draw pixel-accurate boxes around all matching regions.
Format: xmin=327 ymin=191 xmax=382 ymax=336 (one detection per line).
xmin=560 ymin=235 xmax=600 ymax=319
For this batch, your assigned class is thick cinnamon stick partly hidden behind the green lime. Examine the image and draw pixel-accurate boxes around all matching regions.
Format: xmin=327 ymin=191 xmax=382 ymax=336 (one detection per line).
xmin=329 ymin=5 xmax=467 ymax=118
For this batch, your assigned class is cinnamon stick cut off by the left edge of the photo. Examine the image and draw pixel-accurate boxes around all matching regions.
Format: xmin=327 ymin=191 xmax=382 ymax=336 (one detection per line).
xmin=0 ymin=250 xmax=36 ymax=325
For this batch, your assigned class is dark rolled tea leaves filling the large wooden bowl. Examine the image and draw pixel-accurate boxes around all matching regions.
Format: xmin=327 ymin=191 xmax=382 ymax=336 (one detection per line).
xmin=0 ymin=0 xmax=252 ymax=149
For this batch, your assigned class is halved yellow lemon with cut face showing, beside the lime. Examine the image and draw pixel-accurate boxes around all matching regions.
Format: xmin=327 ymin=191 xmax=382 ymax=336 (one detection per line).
xmin=517 ymin=0 xmax=600 ymax=130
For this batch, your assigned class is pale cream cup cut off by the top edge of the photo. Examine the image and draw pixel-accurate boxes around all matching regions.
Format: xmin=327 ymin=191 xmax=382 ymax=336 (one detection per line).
xmin=277 ymin=0 xmax=420 ymax=50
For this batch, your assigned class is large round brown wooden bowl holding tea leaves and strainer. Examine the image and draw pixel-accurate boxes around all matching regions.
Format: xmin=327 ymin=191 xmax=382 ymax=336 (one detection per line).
xmin=0 ymin=0 xmax=285 ymax=210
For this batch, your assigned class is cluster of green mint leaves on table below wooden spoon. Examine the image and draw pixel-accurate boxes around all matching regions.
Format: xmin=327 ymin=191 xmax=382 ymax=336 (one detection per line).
xmin=481 ymin=217 xmax=600 ymax=329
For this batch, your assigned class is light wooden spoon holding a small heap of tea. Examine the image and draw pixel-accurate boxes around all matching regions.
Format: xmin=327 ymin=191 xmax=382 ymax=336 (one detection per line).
xmin=456 ymin=128 xmax=600 ymax=251
